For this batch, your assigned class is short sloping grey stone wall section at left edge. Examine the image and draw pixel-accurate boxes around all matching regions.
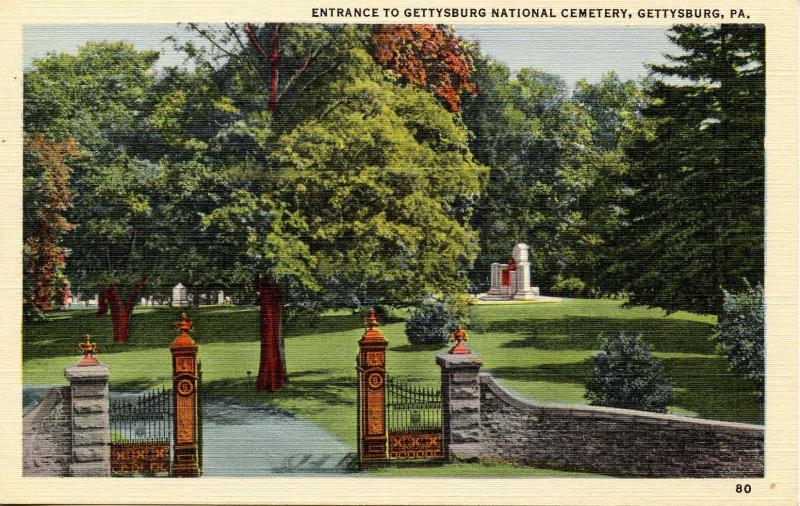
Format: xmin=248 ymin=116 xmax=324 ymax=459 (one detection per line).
xmin=22 ymin=386 xmax=72 ymax=476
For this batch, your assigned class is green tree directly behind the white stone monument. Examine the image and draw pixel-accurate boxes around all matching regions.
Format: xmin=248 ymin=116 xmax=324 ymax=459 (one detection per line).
xmin=463 ymin=59 xmax=589 ymax=288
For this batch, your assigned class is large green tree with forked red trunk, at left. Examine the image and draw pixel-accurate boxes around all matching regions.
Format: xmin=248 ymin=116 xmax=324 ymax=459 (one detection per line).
xmin=24 ymin=42 xmax=220 ymax=342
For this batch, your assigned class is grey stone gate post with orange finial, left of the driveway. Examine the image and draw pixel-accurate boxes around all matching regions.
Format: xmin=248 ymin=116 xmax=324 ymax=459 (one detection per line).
xmin=64 ymin=335 xmax=111 ymax=476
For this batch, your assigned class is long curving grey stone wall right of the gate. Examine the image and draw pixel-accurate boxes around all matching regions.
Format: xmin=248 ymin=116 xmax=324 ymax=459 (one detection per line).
xmin=480 ymin=373 xmax=764 ymax=478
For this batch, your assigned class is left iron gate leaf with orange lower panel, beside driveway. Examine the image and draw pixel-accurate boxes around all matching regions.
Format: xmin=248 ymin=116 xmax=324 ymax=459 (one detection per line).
xmin=109 ymin=388 xmax=172 ymax=476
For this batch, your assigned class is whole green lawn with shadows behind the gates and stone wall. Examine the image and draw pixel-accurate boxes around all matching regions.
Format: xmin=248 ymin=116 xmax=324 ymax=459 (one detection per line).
xmin=23 ymin=299 xmax=763 ymax=475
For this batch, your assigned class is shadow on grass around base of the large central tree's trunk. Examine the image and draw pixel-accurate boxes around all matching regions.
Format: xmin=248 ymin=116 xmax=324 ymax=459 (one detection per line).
xmin=198 ymin=371 xmax=356 ymax=406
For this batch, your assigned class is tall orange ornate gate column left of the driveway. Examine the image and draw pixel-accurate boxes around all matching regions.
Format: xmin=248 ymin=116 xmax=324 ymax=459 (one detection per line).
xmin=171 ymin=313 xmax=200 ymax=477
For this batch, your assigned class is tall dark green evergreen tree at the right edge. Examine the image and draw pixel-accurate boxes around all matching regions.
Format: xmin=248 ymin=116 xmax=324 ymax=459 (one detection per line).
xmin=616 ymin=25 xmax=765 ymax=313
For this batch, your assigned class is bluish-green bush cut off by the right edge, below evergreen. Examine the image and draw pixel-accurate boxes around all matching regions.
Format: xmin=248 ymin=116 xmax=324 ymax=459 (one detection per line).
xmin=716 ymin=285 xmax=764 ymax=391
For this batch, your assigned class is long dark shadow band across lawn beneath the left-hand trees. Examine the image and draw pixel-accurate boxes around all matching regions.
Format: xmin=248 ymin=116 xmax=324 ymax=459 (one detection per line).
xmin=22 ymin=306 xmax=363 ymax=360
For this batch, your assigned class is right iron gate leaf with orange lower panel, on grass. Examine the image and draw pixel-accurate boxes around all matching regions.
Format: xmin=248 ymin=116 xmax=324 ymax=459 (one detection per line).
xmin=386 ymin=377 xmax=444 ymax=460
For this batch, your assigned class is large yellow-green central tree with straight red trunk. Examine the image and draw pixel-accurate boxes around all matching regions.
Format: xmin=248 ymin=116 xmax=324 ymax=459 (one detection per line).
xmin=178 ymin=24 xmax=481 ymax=390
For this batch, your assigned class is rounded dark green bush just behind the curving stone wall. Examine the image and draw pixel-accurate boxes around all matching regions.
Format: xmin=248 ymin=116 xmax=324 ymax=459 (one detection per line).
xmin=586 ymin=332 xmax=672 ymax=413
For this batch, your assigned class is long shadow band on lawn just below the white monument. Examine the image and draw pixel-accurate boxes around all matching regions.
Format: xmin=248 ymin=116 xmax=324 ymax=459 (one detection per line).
xmin=486 ymin=316 xmax=715 ymax=354
